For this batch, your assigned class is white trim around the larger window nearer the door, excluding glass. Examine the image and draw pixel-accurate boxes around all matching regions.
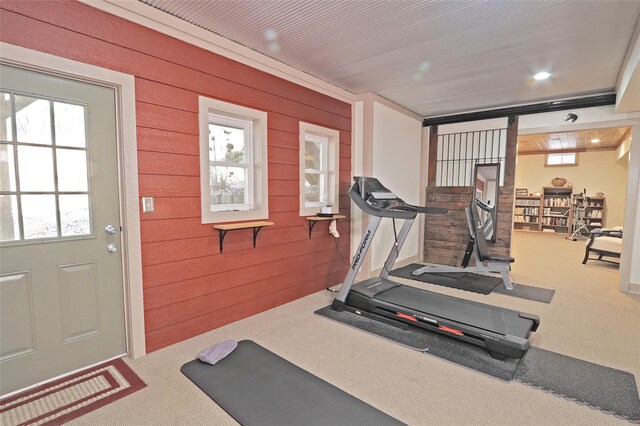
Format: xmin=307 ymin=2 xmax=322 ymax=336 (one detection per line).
xmin=198 ymin=96 xmax=269 ymax=223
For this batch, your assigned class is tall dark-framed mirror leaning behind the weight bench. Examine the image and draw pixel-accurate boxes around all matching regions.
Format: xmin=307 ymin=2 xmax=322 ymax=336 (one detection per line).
xmin=473 ymin=163 xmax=500 ymax=243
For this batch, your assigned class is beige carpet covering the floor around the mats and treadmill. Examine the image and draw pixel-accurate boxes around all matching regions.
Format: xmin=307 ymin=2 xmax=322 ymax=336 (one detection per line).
xmin=69 ymin=233 xmax=640 ymax=425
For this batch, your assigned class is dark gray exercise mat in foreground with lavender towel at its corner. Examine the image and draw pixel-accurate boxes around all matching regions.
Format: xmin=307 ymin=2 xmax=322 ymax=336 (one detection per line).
xmin=180 ymin=340 xmax=403 ymax=426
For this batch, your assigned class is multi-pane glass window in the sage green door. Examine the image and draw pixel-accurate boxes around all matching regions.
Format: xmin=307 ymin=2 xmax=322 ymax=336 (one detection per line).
xmin=0 ymin=91 xmax=92 ymax=242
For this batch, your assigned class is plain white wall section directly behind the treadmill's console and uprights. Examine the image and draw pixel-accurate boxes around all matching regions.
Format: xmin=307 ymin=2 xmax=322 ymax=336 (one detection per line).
xmin=371 ymin=102 xmax=425 ymax=270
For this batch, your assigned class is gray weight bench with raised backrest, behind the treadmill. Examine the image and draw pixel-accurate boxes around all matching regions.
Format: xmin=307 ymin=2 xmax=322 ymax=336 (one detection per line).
xmin=411 ymin=200 xmax=515 ymax=290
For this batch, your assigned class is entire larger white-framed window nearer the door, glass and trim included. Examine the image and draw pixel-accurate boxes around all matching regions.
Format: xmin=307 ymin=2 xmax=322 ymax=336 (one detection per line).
xmin=199 ymin=96 xmax=269 ymax=223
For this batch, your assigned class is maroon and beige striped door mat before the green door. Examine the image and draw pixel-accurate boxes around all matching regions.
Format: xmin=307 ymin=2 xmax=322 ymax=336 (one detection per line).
xmin=0 ymin=359 xmax=146 ymax=426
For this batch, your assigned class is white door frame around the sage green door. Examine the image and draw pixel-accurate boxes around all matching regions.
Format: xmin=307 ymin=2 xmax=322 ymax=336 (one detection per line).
xmin=0 ymin=42 xmax=146 ymax=359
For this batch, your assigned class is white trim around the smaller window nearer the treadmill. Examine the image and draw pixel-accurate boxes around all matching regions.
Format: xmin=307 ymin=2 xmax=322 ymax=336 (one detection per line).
xmin=299 ymin=121 xmax=340 ymax=216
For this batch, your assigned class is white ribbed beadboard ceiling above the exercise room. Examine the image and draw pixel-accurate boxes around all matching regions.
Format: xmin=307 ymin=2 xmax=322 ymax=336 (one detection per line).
xmin=140 ymin=0 xmax=640 ymax=117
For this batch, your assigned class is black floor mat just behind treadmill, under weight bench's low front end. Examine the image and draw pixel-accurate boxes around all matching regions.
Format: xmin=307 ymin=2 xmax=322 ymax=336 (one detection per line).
xmin=391 ymin=263 xmax=502 ymax=294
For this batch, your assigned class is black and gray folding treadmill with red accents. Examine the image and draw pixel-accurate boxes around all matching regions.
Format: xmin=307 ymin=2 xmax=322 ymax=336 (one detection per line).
xmin=331 ymin=177 xmax=540 ymax=359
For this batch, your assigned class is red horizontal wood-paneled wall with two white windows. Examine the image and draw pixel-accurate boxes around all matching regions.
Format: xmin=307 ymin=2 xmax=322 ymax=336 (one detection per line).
xmin=0 ymin=1 xmax=351 ymax=351
